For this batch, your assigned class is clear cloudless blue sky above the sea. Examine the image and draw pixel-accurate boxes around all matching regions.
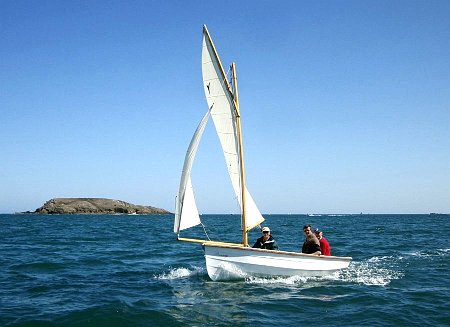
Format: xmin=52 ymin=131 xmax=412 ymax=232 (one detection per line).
xmin=0 ymin=0 xmax=450 ymax=214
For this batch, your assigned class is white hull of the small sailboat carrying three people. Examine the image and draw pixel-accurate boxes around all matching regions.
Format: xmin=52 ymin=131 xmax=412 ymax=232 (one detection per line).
xmin=203 ymin=243 xmax=351 ymax=281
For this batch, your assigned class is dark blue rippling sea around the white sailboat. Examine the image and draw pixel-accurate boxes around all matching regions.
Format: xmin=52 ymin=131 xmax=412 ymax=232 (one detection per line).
xmin=0 ymin=214 xmax=450 ymax=327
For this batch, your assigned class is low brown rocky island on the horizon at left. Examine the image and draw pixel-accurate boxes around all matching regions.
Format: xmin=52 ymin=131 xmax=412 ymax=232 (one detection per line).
xmin=24 ymin=198 xmax=170 ymax=215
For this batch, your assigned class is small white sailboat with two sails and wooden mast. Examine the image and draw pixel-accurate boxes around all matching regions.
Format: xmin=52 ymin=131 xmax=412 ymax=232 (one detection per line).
xmin=174 ymin=26 xmax=351 ymax=281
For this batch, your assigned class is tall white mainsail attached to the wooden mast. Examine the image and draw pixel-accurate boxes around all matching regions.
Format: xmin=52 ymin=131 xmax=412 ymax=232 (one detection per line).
xmin=202 ymin=27 xmax=264 ymax=230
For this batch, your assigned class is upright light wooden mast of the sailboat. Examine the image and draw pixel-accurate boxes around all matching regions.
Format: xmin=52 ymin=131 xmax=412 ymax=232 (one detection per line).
xmin=231 ymin=62 xmax=248 ymax=246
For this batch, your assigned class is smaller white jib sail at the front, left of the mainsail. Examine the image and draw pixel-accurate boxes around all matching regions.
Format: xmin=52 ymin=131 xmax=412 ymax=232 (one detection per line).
xmin=173 ymin=110 xmax=210 ymax=233
